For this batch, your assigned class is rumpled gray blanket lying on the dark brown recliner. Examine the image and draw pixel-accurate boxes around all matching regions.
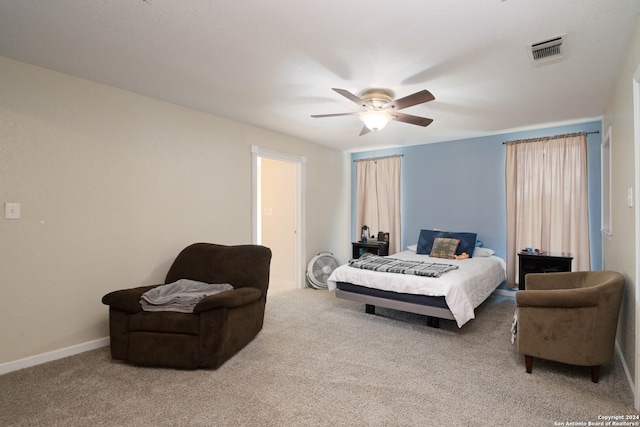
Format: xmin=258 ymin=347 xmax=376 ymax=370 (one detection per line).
xmin=140 ymin=279 xmax=233 ymax=313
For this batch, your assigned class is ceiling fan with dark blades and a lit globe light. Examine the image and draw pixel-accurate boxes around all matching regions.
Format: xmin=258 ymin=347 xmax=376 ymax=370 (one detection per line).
xmin=311 ymin=88 xmax=436 ymax=136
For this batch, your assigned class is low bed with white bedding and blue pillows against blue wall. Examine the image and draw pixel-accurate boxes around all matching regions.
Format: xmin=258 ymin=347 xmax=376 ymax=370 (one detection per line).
xmin=327 ymin=230 xmax=506 ymax=328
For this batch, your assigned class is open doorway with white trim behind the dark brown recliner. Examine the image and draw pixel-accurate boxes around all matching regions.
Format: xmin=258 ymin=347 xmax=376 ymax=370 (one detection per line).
xmin=252 ymin=146 xmax=305 ymax=294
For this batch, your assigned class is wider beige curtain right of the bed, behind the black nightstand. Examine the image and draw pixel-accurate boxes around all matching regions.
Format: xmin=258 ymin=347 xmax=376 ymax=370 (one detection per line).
xmin=506 ymin=133 xmax=591 ymax=284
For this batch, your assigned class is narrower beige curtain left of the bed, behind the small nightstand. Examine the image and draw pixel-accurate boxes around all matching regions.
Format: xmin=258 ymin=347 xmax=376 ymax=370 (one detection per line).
xmin=356 ymin=156 xmax=401 ymax=255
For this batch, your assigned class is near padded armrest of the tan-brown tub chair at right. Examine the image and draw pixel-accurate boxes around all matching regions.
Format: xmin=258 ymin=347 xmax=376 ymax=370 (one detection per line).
xmin=516 ymin=288 xmax=599 ymax=308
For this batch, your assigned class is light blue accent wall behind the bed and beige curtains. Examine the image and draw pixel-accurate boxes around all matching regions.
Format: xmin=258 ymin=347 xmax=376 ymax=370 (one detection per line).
xmin=351 ymin=121 xmax=602 ymax=270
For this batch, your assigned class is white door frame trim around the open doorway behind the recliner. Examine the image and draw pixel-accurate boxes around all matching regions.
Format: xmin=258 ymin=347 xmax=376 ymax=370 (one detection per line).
xmin=251 ymin=145 xmax=307 ymax=288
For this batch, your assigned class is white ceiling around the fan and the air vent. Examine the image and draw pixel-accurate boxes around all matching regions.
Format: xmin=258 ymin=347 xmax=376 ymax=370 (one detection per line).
xmin=0 ymin=0 xmax=640 ymax=151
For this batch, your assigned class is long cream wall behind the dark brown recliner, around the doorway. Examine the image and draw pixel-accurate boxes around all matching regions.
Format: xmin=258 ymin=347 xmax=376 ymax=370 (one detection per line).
xmin=0 ymin=58 xmax=349 ymax=364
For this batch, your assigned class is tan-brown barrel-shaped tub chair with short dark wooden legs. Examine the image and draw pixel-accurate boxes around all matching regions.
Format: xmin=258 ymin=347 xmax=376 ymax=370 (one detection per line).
xmin=516 ymin=270 xmax=624 ymax=383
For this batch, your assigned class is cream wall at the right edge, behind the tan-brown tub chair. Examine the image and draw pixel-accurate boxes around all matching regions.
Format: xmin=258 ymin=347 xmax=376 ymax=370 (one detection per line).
xmin=602 ymin=15 xmax=640 ymax=384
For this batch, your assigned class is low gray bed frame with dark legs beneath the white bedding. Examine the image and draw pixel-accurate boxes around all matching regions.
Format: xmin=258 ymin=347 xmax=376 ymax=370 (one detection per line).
xmin=335 ymin=282 xmax=455 ymax=328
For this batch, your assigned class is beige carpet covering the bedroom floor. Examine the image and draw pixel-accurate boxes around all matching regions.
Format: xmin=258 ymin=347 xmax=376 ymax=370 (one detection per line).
xmin=0 ymin=289 xmax=636 ymax=427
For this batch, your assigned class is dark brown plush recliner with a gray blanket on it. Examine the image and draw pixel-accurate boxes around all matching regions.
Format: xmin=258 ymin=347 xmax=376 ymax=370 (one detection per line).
xmin=102 ymin=243 xmax=271 ymax=369
